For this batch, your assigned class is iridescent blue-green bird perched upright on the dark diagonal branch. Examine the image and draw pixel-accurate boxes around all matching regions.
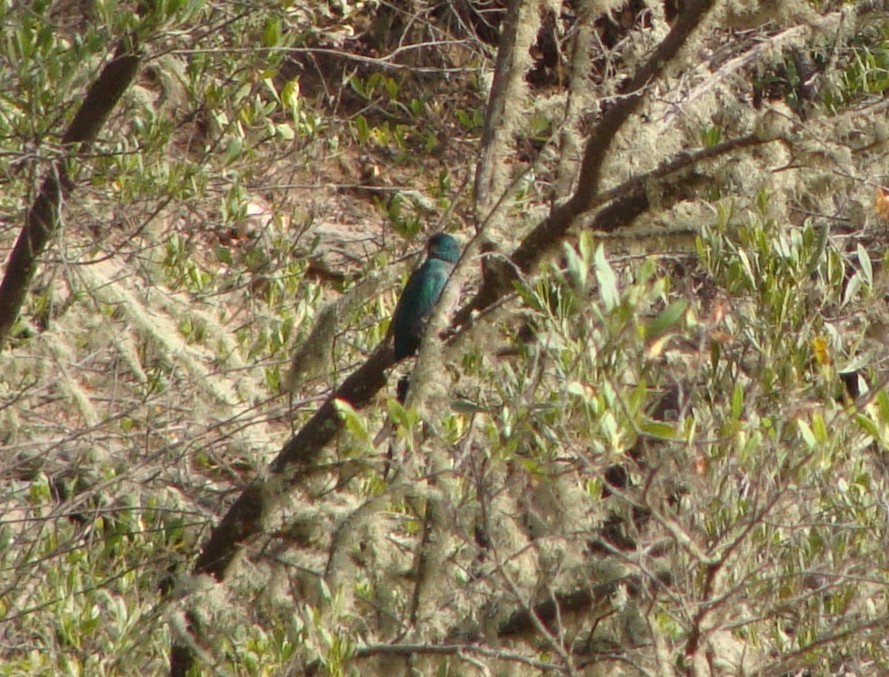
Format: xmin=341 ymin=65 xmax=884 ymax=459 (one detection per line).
xmin=392 ymin=233 xmax=460 ymax=360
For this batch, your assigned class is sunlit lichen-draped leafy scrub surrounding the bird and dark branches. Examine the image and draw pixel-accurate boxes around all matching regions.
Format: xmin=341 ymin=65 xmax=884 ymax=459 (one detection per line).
xmin=0 ymin=0 xmax=889 ymax=675
